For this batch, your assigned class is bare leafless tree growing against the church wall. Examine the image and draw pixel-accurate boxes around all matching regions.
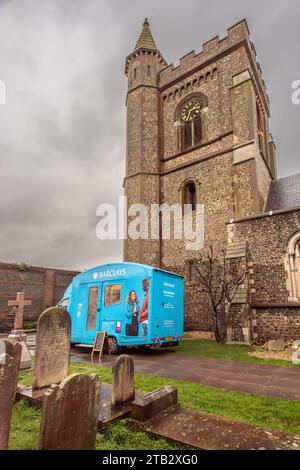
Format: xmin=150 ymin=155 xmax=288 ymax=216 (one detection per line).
xmin=195 ymin=245 xmax=247 ymax=343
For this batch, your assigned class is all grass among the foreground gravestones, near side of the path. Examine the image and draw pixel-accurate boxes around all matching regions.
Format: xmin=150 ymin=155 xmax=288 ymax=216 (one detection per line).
xmin=10 ymin=363 xmax=300 ymax=450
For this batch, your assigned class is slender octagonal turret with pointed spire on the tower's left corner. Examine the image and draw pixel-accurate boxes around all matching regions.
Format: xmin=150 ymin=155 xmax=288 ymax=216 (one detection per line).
xmin=124 ymin=18 xmax=167 ymax=266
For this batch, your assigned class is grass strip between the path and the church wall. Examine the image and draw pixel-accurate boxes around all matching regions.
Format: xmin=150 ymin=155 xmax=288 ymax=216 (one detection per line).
xmin=174 ymin=339 xmax=297 ymax=367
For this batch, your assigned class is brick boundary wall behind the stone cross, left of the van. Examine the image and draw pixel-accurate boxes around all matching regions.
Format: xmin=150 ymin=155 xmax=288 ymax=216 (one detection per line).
xmin=0 ymin=262 xmax=79 ymax=332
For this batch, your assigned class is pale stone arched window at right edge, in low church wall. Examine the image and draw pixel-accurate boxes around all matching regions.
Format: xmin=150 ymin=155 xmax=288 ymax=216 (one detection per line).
xmin=286 ymin=232 xmax=300 ymax=302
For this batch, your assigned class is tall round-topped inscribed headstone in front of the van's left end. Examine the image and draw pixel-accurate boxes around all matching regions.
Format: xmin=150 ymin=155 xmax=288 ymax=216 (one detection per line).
xmin=33 ymin=307 xmax=71 ymax=389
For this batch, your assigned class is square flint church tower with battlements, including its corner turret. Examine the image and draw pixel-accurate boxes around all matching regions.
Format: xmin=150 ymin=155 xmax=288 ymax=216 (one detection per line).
xmin=124 ymin=19 xmax=276 ymax=331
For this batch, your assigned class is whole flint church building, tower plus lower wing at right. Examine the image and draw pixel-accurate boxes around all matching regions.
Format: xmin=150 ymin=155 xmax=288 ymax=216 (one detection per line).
xmin=124 ymin=20 xmax=300 ymax=342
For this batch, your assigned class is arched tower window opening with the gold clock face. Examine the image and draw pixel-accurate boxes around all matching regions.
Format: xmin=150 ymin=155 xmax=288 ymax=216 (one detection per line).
xmin=175 ymin=93 xmax=207 ymax=152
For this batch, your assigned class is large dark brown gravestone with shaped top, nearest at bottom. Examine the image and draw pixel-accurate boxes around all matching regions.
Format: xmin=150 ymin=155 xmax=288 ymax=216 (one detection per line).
xmin=39 ymin=374 xmax=101 ymax=450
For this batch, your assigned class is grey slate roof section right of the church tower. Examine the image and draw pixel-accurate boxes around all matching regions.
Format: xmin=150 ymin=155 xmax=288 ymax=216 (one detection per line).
xmin=267 ymin=173 xmax=300 ymax=211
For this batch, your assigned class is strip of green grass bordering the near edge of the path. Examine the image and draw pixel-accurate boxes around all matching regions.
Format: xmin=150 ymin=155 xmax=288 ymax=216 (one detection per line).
xmin=16 ymin=363 xmax=300 ymax=435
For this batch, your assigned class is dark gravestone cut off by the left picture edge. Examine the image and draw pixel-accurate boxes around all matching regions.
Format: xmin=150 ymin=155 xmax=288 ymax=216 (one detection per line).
xmin=0 ymin=340 xmax=22 ymax=450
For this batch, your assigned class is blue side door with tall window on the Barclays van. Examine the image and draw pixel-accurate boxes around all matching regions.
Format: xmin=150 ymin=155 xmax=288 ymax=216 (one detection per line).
xmin=79 ymin=283 xmax=101 ymax=344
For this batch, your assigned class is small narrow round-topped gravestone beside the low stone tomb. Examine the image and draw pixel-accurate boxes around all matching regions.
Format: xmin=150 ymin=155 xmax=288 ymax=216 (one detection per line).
xmin=111 ymin=354 xmax=134 ymax=408
